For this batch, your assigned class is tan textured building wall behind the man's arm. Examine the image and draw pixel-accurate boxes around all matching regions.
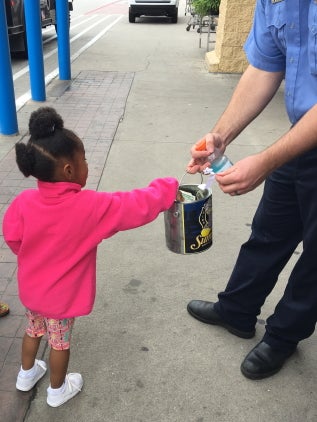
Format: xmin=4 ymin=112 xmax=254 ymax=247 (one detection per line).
xmin=206 ymin=0 xmax=256 ymax=73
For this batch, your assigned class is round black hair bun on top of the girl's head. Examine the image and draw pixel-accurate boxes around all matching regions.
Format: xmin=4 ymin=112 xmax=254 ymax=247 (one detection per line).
xmin=29 ymin=107 xmax=64 ymax=139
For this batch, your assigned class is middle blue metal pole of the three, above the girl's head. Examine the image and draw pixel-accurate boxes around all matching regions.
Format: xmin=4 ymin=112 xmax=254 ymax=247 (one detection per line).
xmin=24 ymin=0 xmax=46 ymax=101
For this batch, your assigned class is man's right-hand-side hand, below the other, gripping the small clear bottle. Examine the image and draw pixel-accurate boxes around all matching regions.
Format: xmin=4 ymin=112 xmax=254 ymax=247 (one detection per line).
xmin=216 ymin=153 xmax=270 ymax=196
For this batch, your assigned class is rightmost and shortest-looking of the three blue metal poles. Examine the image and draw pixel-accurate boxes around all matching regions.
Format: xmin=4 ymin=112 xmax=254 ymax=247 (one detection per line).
xmin=56 ymin=0 xmax=71 ymax=80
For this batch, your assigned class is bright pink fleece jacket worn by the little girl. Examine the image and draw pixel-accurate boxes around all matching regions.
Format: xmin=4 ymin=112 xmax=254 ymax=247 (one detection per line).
xmin=3 ymin=178 xmax=178 ymax=319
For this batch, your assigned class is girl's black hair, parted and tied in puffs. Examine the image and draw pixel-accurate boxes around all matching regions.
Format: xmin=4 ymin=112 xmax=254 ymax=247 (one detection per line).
xmin=15 ymin=107 xmax=83 ymax=182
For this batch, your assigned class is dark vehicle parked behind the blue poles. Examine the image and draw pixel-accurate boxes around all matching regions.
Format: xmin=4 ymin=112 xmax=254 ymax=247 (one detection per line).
xmin=5 ymin=0 xmax=73 ymax=56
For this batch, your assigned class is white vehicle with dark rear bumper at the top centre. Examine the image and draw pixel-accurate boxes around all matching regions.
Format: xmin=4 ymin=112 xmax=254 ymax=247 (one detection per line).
xmin=129 ymin=0 xmax=179 ymax=23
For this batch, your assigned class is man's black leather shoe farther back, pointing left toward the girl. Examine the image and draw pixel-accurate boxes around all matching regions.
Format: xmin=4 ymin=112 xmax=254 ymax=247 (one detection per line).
xmin=187 ymin=300 xmax=255 ymax=338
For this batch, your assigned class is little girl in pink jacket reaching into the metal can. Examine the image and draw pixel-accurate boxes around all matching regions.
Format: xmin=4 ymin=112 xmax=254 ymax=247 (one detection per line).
xmin=3 ymin=107 xmax=178 ymax=407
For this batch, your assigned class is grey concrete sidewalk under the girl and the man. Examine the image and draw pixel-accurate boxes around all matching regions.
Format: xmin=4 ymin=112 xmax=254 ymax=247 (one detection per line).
xmin=0 ymin=4 xmax=317 ymax=422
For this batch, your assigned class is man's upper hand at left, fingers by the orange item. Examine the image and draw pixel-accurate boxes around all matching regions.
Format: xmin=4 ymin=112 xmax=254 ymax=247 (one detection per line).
xmin=186 ymin=132 xmax=226 ymax=174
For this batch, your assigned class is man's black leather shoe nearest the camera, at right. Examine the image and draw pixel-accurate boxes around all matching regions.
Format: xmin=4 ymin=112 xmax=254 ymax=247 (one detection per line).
xmin=240 ymin=341 xmax=296 ymax=380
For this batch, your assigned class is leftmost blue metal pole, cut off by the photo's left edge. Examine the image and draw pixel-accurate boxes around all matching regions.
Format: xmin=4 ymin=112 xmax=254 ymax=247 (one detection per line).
xmin=0 ymin=0 xmax=18 ymax=135
